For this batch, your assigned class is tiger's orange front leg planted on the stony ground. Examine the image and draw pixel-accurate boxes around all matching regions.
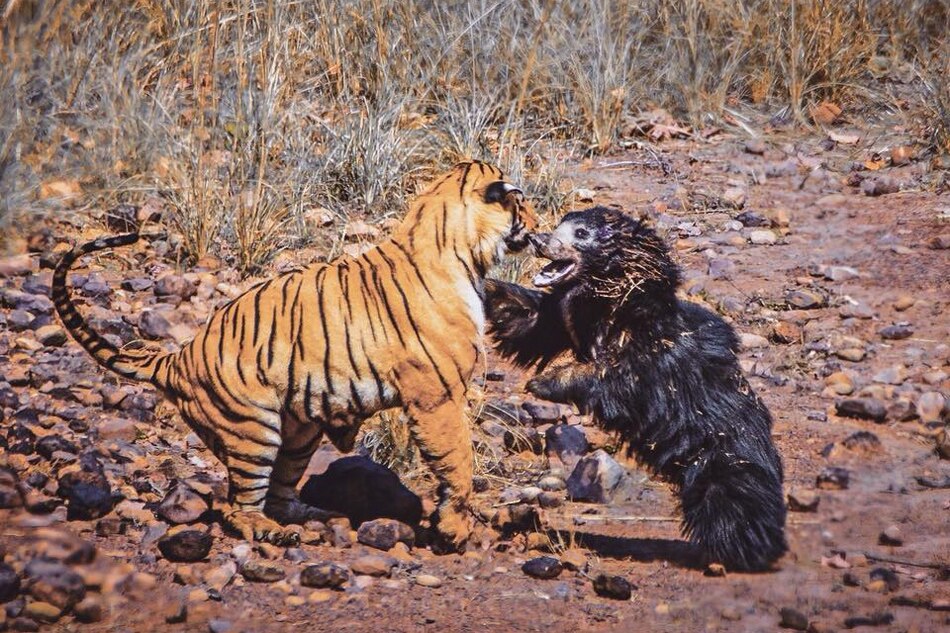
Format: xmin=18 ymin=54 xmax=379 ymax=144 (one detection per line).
xmin=399 ymin=362 xmax=474 ymax=550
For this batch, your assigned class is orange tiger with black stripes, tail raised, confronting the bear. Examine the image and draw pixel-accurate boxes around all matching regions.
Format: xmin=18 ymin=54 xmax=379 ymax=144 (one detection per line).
xmin=51 ymin=161 xmax=538 ymax=549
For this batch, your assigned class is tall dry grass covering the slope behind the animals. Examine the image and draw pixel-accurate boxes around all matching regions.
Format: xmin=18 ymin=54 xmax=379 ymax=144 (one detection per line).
xmin=0 ymin=0 xmax=950 ymax=260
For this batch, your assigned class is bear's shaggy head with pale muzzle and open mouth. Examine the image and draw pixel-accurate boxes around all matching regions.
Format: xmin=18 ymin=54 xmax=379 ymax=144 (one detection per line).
xmin=532 ymin=207 xmax=679 ymax=303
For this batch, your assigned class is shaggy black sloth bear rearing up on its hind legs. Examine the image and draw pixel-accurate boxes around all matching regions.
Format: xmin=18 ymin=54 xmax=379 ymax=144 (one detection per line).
xmin=485 ymin=207 xmax=787 ymax=571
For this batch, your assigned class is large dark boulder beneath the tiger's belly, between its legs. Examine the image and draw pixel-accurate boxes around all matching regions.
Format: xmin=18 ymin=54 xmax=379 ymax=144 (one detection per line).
xmin=300 ymin=455 xmax=422 ymax=525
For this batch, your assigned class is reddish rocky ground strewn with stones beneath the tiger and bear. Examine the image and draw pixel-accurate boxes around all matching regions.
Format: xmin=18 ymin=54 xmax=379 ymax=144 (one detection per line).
xmin=0 ymin=110 xmax=950 ymax=632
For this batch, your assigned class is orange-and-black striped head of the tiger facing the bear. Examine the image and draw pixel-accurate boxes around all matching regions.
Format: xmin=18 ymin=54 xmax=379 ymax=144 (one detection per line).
xmin=402 ymin=161 xmax=538 ymax=274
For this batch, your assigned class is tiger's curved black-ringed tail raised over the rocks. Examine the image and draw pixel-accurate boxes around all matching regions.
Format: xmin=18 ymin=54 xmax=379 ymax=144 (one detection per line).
xmin=50 ymin=233 xmax=169 ymax=382
